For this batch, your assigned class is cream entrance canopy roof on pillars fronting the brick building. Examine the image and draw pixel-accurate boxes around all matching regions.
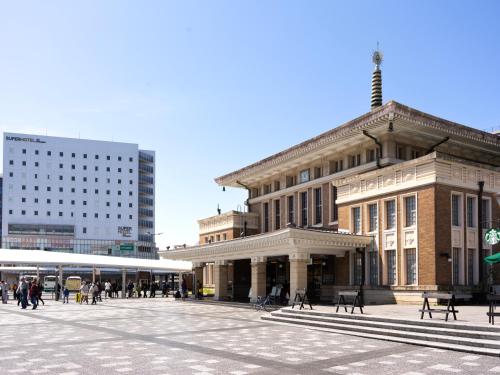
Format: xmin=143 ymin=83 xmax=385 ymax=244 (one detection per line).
xmin=159 ymin=228 xmax=373 ymax=262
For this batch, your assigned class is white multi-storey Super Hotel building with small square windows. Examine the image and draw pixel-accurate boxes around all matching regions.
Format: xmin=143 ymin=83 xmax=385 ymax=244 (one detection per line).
xmin=2 ymin=133 xmax=156 ymax=258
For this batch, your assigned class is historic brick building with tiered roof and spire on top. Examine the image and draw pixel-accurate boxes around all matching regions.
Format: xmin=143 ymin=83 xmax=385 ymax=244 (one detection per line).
xmin=162 ymin=52 xmax=500 ymax=303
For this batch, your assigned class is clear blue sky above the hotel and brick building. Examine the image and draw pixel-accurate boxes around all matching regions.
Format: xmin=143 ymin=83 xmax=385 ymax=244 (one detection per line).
xmin=0 ymin=0 xmax=500 ymax=248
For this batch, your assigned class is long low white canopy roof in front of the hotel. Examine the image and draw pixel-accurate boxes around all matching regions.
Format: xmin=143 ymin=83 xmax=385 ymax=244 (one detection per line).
xmin=0 ymin=249 xmax=192 ymax=272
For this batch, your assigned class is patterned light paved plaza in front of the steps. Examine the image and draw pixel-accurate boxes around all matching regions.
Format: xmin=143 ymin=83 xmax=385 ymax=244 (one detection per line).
xmin=0 ymin=298 xmax=500 ymax=375
